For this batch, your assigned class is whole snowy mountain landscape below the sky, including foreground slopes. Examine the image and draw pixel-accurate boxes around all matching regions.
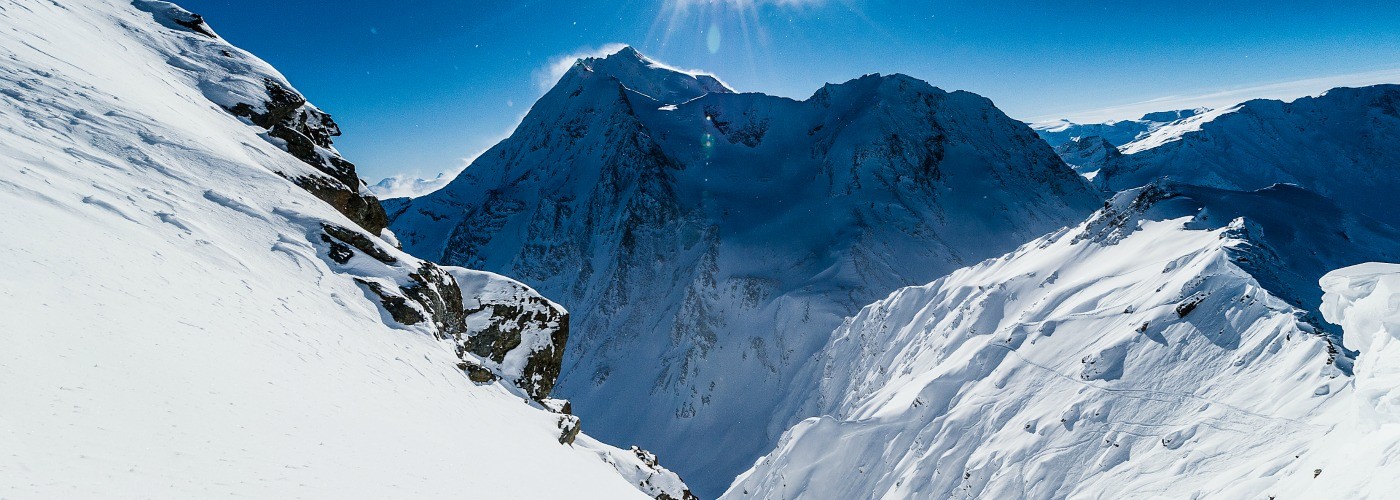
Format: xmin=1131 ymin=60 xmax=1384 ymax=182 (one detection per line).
xmin=0 ymin=0 xmax=1400 ymax=500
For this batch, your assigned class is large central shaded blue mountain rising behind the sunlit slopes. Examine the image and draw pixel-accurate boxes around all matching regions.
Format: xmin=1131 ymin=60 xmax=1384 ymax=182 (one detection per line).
xmin=391 ymin=49 xmax=1099 ymax=493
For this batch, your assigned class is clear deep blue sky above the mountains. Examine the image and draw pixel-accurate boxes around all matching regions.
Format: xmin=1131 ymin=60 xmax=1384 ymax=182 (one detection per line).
xmin=178 ymin=0 xmax=1400 ymax=182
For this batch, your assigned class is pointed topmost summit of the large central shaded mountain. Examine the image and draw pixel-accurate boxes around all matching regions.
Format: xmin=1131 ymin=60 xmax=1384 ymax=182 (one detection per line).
xmin=573 ymin=45 xmax=734 ymax=104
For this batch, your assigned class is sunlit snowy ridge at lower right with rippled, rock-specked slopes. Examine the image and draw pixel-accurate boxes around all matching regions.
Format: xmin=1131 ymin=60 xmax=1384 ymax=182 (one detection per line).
xmin=725 ymin=185 xmax=1400 ymax=499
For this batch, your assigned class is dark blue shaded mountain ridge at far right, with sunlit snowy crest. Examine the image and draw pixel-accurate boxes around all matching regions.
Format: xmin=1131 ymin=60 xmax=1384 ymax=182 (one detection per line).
xmin=1095 ymin=85 xmax=1400 ymax=225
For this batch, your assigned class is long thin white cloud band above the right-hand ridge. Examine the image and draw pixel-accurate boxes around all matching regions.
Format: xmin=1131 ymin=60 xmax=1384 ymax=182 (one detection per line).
xmin=1035 ymin=69 xmax=1400 ymax=123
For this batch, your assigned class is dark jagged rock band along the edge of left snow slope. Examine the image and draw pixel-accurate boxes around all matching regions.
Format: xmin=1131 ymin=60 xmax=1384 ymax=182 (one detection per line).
xmin=134 ymin=0 xmax=568 ymax=401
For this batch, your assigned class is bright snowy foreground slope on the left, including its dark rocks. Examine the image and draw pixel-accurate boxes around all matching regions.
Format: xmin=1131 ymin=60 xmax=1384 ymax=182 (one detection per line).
xmin=0 ymin=0 xmax=687 ymax=499
